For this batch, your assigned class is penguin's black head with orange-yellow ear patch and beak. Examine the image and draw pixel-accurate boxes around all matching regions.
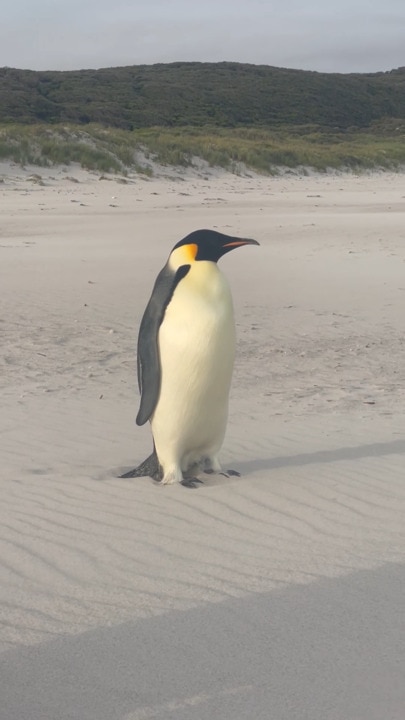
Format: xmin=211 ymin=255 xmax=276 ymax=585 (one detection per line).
xmin=169 ymin=230 xmax=259 ymax=267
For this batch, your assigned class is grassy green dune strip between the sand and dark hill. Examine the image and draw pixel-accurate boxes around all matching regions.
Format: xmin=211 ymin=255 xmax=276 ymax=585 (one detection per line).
xmin=0 ymin=121 xmax=405 ymax=175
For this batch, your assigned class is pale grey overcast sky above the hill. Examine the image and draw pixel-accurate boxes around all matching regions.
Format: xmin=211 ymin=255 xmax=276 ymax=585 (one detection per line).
xmin=0 ymin=0 xmax=405 ymax=72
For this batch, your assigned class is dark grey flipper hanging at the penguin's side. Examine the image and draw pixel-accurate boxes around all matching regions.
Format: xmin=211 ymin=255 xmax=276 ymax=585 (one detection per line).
xmin=136 ymin=265 xmax=190 ymax=425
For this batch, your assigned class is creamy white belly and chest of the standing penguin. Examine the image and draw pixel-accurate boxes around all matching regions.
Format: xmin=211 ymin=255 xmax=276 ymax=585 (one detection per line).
xmin=151 ymin=261 xmax=235 ymax=482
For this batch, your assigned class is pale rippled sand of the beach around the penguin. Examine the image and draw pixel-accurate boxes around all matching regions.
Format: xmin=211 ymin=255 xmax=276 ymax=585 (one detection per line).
xmin=0 ymin=165 xmax=405 ymax=720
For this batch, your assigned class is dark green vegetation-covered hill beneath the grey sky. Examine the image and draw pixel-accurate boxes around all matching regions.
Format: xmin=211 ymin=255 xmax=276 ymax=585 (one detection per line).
xmin=0 ymin=62 xmax=405 ymax=130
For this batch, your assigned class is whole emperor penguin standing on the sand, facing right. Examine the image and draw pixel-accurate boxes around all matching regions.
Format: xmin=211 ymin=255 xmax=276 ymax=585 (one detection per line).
xmin=121 ymin=230 xmax=259 ymax=487
